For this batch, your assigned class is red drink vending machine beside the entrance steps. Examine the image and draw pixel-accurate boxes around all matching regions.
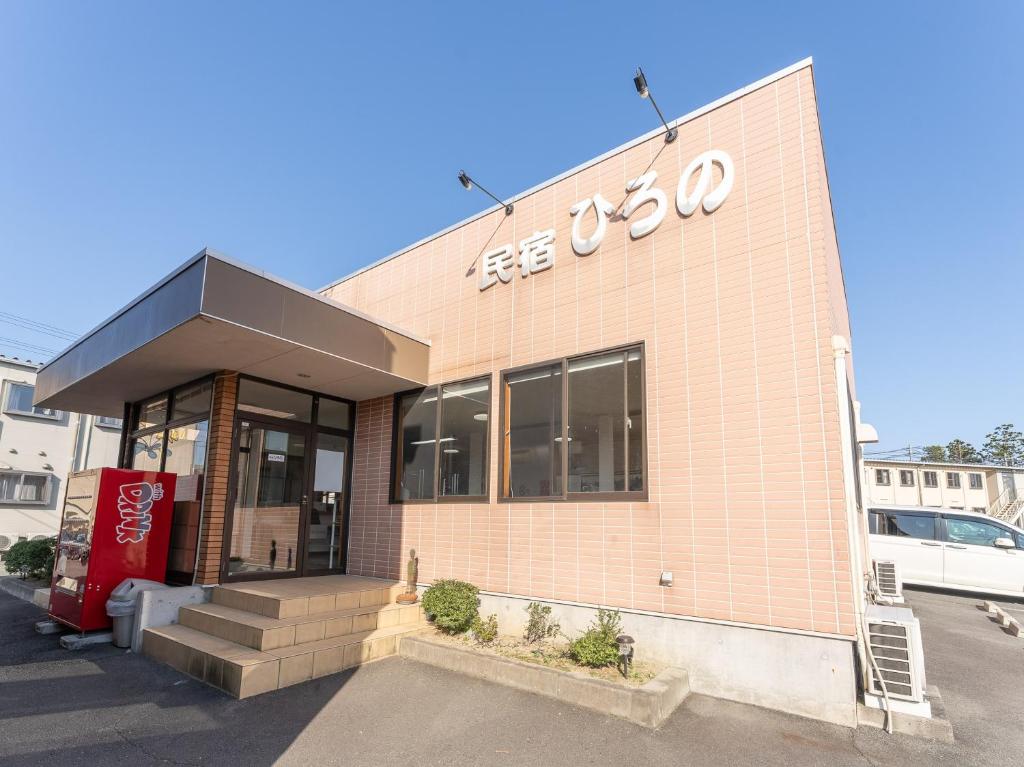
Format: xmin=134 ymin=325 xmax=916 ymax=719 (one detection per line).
xmin=50 ymin=469 xmax=177 ymax=631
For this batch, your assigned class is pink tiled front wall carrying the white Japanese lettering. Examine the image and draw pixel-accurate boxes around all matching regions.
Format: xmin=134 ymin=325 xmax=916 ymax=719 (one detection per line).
xmin=329 ymin=68 xmax=853 ymax=635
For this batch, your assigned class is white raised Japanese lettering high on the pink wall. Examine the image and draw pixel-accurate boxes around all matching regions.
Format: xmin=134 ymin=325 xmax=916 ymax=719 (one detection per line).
xmin=480 ymin=150 xmax=735 ymax=291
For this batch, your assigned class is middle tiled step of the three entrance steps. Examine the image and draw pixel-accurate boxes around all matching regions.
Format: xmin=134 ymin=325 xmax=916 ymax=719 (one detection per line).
xmin=178 ymin=602 xmax=424 ymax=651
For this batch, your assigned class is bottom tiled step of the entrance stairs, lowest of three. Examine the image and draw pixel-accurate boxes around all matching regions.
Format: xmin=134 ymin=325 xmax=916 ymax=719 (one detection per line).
xmin=142 ymin=624 xmax=423 ymax=698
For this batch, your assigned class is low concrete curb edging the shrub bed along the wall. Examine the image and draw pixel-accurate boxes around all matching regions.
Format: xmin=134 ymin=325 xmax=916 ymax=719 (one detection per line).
xmin=398 ymin=636 xmax=690 ymax=727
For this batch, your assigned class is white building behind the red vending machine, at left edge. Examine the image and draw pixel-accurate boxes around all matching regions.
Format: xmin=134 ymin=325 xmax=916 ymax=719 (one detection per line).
xmin=0 ymin=354 xmax=121 ymax=551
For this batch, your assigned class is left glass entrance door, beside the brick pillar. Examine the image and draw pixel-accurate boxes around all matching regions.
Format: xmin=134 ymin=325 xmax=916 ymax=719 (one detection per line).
xmin=227 ymin=419 xmax=309 ymax=578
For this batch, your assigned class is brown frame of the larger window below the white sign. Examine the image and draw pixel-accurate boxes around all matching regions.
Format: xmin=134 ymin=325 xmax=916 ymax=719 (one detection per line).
xmin=498 ymin=341 xmax=649 ymax=504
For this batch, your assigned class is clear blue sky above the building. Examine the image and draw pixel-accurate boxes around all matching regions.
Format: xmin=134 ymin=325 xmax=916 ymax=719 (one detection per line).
xmin=0 ymin=0 xmax=1024 ymax=448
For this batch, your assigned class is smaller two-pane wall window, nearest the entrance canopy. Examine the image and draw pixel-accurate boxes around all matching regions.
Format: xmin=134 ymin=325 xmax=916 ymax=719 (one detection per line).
xmin=394 ymin=378 xmax=490 ymax=502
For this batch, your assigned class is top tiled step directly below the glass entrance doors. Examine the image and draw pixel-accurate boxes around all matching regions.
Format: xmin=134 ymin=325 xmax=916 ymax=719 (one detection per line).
xmin=212 ymin=576 xmax=404 ymax=619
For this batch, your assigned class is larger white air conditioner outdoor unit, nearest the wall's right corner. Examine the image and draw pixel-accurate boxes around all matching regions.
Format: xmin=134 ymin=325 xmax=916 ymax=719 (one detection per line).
xmin=866 ymin=604 xmax=925 ymax=704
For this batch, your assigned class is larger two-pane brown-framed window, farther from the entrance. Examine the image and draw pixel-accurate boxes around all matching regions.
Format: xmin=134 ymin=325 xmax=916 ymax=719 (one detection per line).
xmin=502 ymin=346 xmax=646 ymax=500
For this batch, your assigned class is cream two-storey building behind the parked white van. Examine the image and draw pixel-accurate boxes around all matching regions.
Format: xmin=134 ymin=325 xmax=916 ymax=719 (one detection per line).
xmin=864 ymin=459 xmax=1024 ymax=517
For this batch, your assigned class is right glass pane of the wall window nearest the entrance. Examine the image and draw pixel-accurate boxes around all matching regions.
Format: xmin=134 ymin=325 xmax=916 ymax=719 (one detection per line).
xmin=437 ymin=379 xmax=490 ymax=498
